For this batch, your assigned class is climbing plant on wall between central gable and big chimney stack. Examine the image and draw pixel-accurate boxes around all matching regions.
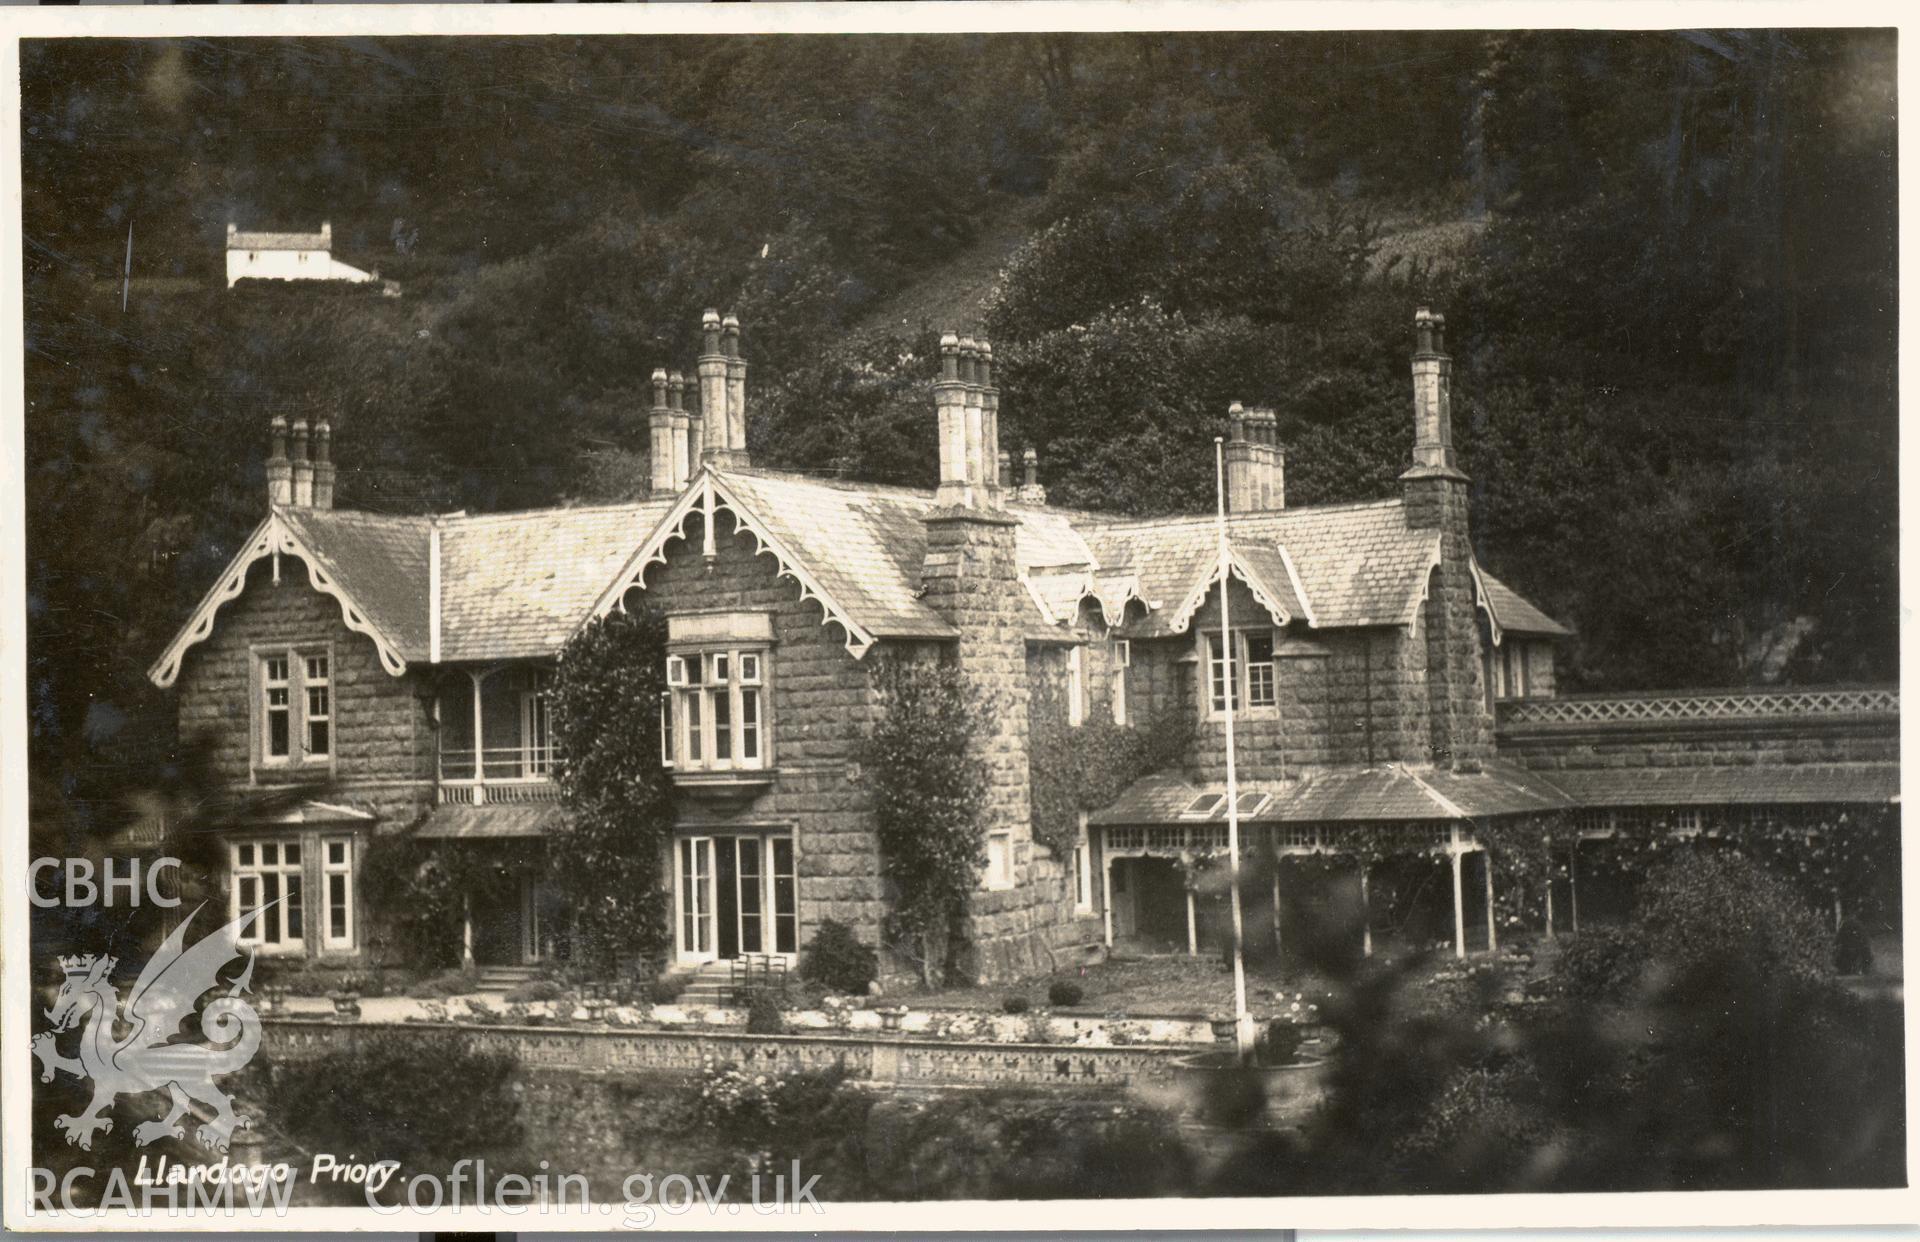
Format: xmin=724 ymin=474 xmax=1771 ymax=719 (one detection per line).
xmin=860 ymin=658 xmax=989 ymax=985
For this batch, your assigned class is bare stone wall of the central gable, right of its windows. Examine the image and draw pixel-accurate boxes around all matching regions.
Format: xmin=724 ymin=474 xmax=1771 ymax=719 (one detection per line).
xmin=643 ymin=511 xmax=885 ymax=946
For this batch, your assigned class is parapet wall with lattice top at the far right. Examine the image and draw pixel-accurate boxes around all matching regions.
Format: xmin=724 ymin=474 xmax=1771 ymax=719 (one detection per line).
xmin=1498 ymin=687 xmax=1901 ymax=770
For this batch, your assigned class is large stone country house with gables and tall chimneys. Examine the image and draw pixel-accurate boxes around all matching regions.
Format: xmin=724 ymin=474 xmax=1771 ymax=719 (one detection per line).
xmin=152 ymin=309 xmax=1899 ymax=977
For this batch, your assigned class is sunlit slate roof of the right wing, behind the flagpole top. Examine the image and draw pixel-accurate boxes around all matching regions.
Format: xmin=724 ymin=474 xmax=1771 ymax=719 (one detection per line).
xmin=1087 ymin=499 xmax=1440 ymax=637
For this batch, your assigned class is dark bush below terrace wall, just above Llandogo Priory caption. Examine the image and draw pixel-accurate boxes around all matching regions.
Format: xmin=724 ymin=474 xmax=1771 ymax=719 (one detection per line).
xmin=275 ymin=1031 xmax=520 ymax=1169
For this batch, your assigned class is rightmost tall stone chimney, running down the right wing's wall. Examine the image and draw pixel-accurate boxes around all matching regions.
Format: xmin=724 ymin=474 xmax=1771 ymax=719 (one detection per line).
xmin=1400 ymin=307 xmax=1494 ymax=764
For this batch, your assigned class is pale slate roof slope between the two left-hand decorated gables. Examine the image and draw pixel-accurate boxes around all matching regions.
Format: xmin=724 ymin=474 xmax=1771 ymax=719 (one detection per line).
xmin=439 ymin=499 xmax=672 ymax=660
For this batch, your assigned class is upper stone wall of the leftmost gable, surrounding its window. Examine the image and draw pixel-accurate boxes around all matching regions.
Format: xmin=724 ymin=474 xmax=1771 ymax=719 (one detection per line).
xmin=177 ymin=557 xmax=434 ymax=822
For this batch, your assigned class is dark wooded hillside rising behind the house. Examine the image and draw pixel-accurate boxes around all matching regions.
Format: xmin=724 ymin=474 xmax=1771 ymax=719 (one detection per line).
xmin=21 ymin=31 xmax=1897 ymax=820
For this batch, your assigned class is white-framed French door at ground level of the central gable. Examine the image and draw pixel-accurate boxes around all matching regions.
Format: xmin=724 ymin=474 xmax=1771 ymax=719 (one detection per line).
xmin=674 ymin=835 xmax=799 ymax=964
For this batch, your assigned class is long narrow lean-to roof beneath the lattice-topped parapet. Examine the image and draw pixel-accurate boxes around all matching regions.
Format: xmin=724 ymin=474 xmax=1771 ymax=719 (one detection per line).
xmin=1551 ymin=764 xmax=1901 ymax=806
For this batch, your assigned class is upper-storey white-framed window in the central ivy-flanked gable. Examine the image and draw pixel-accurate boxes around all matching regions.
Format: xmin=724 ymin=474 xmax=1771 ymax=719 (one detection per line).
xmin=660 ymin=647 xmax=772 ymax=772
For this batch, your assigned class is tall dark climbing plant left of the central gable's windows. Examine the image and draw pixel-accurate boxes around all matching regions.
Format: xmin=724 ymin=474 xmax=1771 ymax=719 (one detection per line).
xmin=547 ymin=609 xmax=674 ymax=969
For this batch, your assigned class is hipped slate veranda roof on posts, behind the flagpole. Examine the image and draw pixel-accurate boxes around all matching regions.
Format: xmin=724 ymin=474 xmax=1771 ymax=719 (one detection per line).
xmin=1089 ymin=762 xmax=1567 ymax=825
